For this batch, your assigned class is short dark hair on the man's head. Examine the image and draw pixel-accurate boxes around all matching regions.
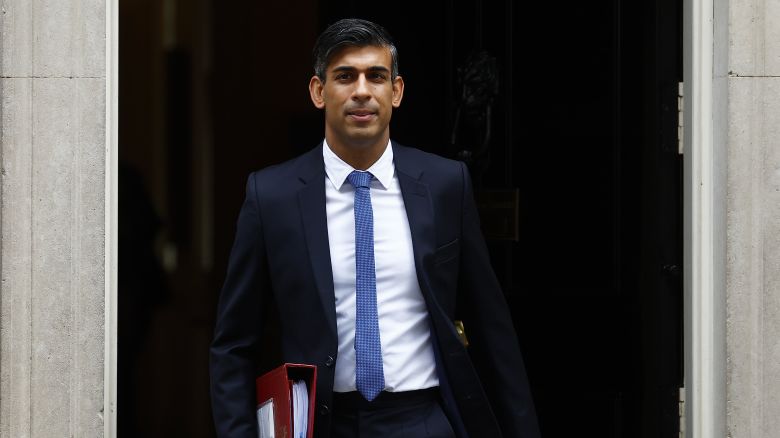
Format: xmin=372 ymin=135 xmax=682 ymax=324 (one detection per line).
xmin=313 ymin=18 xmax=398 ymax=82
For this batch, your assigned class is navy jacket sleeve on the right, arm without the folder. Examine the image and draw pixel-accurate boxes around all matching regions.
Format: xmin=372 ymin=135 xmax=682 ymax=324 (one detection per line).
xmin=458 ymin=163 xmax=539 ymax=438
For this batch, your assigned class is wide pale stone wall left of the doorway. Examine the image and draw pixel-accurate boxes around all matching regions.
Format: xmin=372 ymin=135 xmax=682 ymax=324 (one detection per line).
xmin=0 ymin=0 xmax=107 ymax=438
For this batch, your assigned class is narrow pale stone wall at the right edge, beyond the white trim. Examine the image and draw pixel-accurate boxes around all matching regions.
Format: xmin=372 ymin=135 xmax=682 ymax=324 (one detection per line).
xmin=721 ymin=0 xmax=780 ymax=438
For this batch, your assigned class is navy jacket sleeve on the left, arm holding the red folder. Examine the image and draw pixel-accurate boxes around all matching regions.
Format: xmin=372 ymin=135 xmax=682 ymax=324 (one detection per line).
xmin=210 ymin=174 xmax=268 ymax=438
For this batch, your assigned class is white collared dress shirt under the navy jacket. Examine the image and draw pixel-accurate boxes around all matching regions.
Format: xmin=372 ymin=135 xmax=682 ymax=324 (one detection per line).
xmin=322 ymin=141 xmax=439 ymax=392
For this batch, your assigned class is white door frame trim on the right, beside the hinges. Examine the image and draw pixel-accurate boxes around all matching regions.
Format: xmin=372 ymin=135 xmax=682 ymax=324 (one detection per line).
xmin=683 ymin=0 xmax=726 ymax=438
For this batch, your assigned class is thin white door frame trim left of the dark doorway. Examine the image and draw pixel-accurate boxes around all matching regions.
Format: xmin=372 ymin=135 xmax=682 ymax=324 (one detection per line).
xmin=103 ymin=0 xmax=119 ymax=438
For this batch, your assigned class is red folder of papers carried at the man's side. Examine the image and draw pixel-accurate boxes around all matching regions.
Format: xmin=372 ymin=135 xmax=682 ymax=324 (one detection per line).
xmin=255 ymin=363 xmax=317 ymax=438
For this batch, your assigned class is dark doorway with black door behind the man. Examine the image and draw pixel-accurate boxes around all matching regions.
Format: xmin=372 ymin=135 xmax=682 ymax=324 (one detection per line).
xmin=118 ymin=0 xmax=683 ymax=437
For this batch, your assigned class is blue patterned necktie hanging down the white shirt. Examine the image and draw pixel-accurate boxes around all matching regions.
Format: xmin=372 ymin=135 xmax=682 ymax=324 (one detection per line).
xmin=347 ymin=170 xmax=385 ymax=401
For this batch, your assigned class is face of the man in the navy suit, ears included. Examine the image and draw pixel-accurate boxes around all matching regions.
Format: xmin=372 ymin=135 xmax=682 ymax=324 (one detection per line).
xmin=309 ymin=46 xmax=404 ymax=148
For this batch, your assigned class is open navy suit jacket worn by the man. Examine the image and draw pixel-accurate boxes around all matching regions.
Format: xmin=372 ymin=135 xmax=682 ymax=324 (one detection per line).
xmin=211 ymin=142 xmax=539 ymax=438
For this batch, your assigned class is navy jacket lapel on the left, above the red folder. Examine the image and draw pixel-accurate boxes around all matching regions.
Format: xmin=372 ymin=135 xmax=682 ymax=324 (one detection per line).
xmin=298 ymin=145 xmax=336 ymax=335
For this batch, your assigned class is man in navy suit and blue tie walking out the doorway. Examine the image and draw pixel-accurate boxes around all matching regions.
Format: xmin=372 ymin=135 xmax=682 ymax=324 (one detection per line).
xmin=211 ymin=19 xmax=539 ymax=438
